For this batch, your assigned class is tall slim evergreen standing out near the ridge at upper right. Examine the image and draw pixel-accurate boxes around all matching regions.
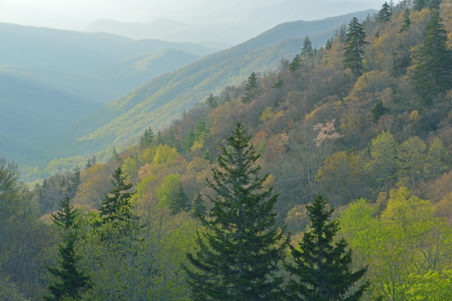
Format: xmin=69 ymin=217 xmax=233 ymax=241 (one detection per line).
xmin=343 ymin=18 xmax=369 ymax=77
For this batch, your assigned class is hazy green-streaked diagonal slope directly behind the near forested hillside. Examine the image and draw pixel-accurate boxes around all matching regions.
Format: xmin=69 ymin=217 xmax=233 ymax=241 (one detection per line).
xmin=57 ymin=11 xmax=369 ymax=155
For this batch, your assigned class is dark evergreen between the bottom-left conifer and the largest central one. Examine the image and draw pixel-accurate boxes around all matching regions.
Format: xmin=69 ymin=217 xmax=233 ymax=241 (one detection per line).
xmin=99 ymin=167 xmax=136 ymax=223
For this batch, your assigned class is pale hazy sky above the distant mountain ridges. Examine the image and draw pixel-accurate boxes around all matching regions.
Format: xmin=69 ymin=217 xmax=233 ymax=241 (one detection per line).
xmin=0 ymin=0 xmax=384 ymax=30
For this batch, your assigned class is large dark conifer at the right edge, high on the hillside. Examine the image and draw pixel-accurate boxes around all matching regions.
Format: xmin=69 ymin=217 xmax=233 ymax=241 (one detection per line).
xmin=413 ymin=11 xmax=452 ymax=103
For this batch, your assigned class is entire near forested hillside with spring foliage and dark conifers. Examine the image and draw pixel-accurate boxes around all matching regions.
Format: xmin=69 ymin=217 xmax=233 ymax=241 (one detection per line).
xmin=0 ymin=0 xmax=452 ymax=301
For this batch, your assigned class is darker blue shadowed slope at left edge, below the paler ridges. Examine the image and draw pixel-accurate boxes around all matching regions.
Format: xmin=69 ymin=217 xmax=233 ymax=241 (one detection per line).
xmin=0 ymin=69 xmax=99 ymax=162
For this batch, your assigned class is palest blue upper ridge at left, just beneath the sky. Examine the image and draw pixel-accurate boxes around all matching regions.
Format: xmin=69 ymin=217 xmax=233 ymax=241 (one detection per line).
xmin=0 ymin=23 xmax=211 ymax=73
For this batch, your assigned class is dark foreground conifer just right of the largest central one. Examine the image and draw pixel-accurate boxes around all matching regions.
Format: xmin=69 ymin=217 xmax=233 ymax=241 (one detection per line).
xmin=287 ymin=196 xmax=367 ymax=301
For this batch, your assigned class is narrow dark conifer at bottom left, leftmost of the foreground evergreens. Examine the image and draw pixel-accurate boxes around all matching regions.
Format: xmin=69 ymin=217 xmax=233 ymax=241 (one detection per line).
xmin=46 ymin=197 xmax=90 ymax=300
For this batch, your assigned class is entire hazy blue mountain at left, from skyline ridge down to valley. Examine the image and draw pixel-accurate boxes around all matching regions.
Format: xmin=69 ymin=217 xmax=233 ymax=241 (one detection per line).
xmin=0 ymin=23 xmax=212 ymax=164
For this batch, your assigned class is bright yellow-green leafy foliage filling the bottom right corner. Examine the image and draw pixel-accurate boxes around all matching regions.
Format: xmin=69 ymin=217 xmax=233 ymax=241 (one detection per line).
xmin=339 ymin=187 xmax=452 ymax=300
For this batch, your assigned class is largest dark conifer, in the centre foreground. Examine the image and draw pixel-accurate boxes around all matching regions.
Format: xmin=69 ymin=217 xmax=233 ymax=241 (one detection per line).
xmin=186 ymin=123 xmax=287 ymax=300
